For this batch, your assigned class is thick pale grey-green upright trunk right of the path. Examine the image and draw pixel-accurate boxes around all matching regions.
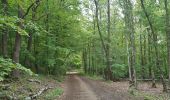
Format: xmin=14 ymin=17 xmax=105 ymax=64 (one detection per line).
xmin=124 ymin=0 xmax=137 ymax=88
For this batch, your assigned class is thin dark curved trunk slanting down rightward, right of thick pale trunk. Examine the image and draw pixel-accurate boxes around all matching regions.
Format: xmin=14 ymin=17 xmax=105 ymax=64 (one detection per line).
xmin=140 ymin=0 xmax=167 ymax=92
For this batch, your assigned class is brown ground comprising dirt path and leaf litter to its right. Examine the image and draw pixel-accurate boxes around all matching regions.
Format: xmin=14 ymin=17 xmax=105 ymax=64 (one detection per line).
xmin=60 ymin=74 xmax=170 ymax=100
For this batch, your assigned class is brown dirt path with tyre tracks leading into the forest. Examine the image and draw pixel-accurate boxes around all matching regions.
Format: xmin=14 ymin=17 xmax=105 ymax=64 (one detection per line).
xmin=60 ymin=75 xmax=142 ymax=100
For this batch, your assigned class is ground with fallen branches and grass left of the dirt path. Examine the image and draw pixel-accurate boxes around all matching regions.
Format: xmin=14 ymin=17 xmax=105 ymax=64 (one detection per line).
xmin=0 ymin=75 xmax=64 ymax=100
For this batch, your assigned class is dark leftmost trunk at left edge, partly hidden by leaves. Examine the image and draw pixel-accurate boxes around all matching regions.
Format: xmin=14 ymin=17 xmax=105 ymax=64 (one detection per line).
xmin=1 ymin=0 xmax=8 ymax=58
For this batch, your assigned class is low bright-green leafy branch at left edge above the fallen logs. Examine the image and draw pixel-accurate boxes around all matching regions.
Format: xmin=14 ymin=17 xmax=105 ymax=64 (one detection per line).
xmin=0 ymin=57 xmax=33 ymax=81
